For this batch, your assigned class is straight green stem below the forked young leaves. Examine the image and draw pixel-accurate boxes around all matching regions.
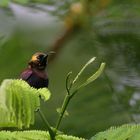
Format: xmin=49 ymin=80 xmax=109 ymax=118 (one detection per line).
xmin=55 ymin=94 xmax=71 ymax=129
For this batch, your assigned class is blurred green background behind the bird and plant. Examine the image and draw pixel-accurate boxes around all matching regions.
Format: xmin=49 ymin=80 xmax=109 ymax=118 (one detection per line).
xmin=0 ymin=0 xmax=140 ymax=138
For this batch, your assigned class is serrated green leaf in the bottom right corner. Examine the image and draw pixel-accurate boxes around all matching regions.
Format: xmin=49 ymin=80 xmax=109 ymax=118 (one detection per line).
xmin=90 ymin=124 xmax=140 ymax=140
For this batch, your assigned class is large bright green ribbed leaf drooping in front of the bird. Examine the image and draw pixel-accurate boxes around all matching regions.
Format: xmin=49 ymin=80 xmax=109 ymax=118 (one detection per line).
xmin=0 ymin=80 xmax=50 ymax=128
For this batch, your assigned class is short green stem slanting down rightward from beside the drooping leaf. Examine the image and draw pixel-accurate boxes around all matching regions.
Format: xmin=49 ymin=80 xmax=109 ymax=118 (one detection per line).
xmin=39 ymin=110 xmax=55 ymax=140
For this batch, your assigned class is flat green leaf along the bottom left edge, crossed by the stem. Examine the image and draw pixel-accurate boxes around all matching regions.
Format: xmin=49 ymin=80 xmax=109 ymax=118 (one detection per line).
xmin=0 ymin=130 xmax=84 ymax=140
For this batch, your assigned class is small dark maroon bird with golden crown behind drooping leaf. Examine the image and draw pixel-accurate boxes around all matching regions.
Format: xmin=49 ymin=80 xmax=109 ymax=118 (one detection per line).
xmin=20 ymin=52 xmax=51 ymax=89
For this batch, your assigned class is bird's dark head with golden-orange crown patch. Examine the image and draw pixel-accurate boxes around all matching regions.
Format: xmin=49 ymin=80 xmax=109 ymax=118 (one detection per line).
xmin=29 ymin=52 xmax=49 ymax=70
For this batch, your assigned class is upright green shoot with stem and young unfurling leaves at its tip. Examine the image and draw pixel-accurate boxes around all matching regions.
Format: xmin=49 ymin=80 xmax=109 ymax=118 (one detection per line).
xmin=56 ymin=57 xmax=105 ymax=129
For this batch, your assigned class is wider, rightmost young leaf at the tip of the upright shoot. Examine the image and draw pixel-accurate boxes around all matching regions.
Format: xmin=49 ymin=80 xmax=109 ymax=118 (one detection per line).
xmin=79 ymin=63 xmax=105 ymax=88
